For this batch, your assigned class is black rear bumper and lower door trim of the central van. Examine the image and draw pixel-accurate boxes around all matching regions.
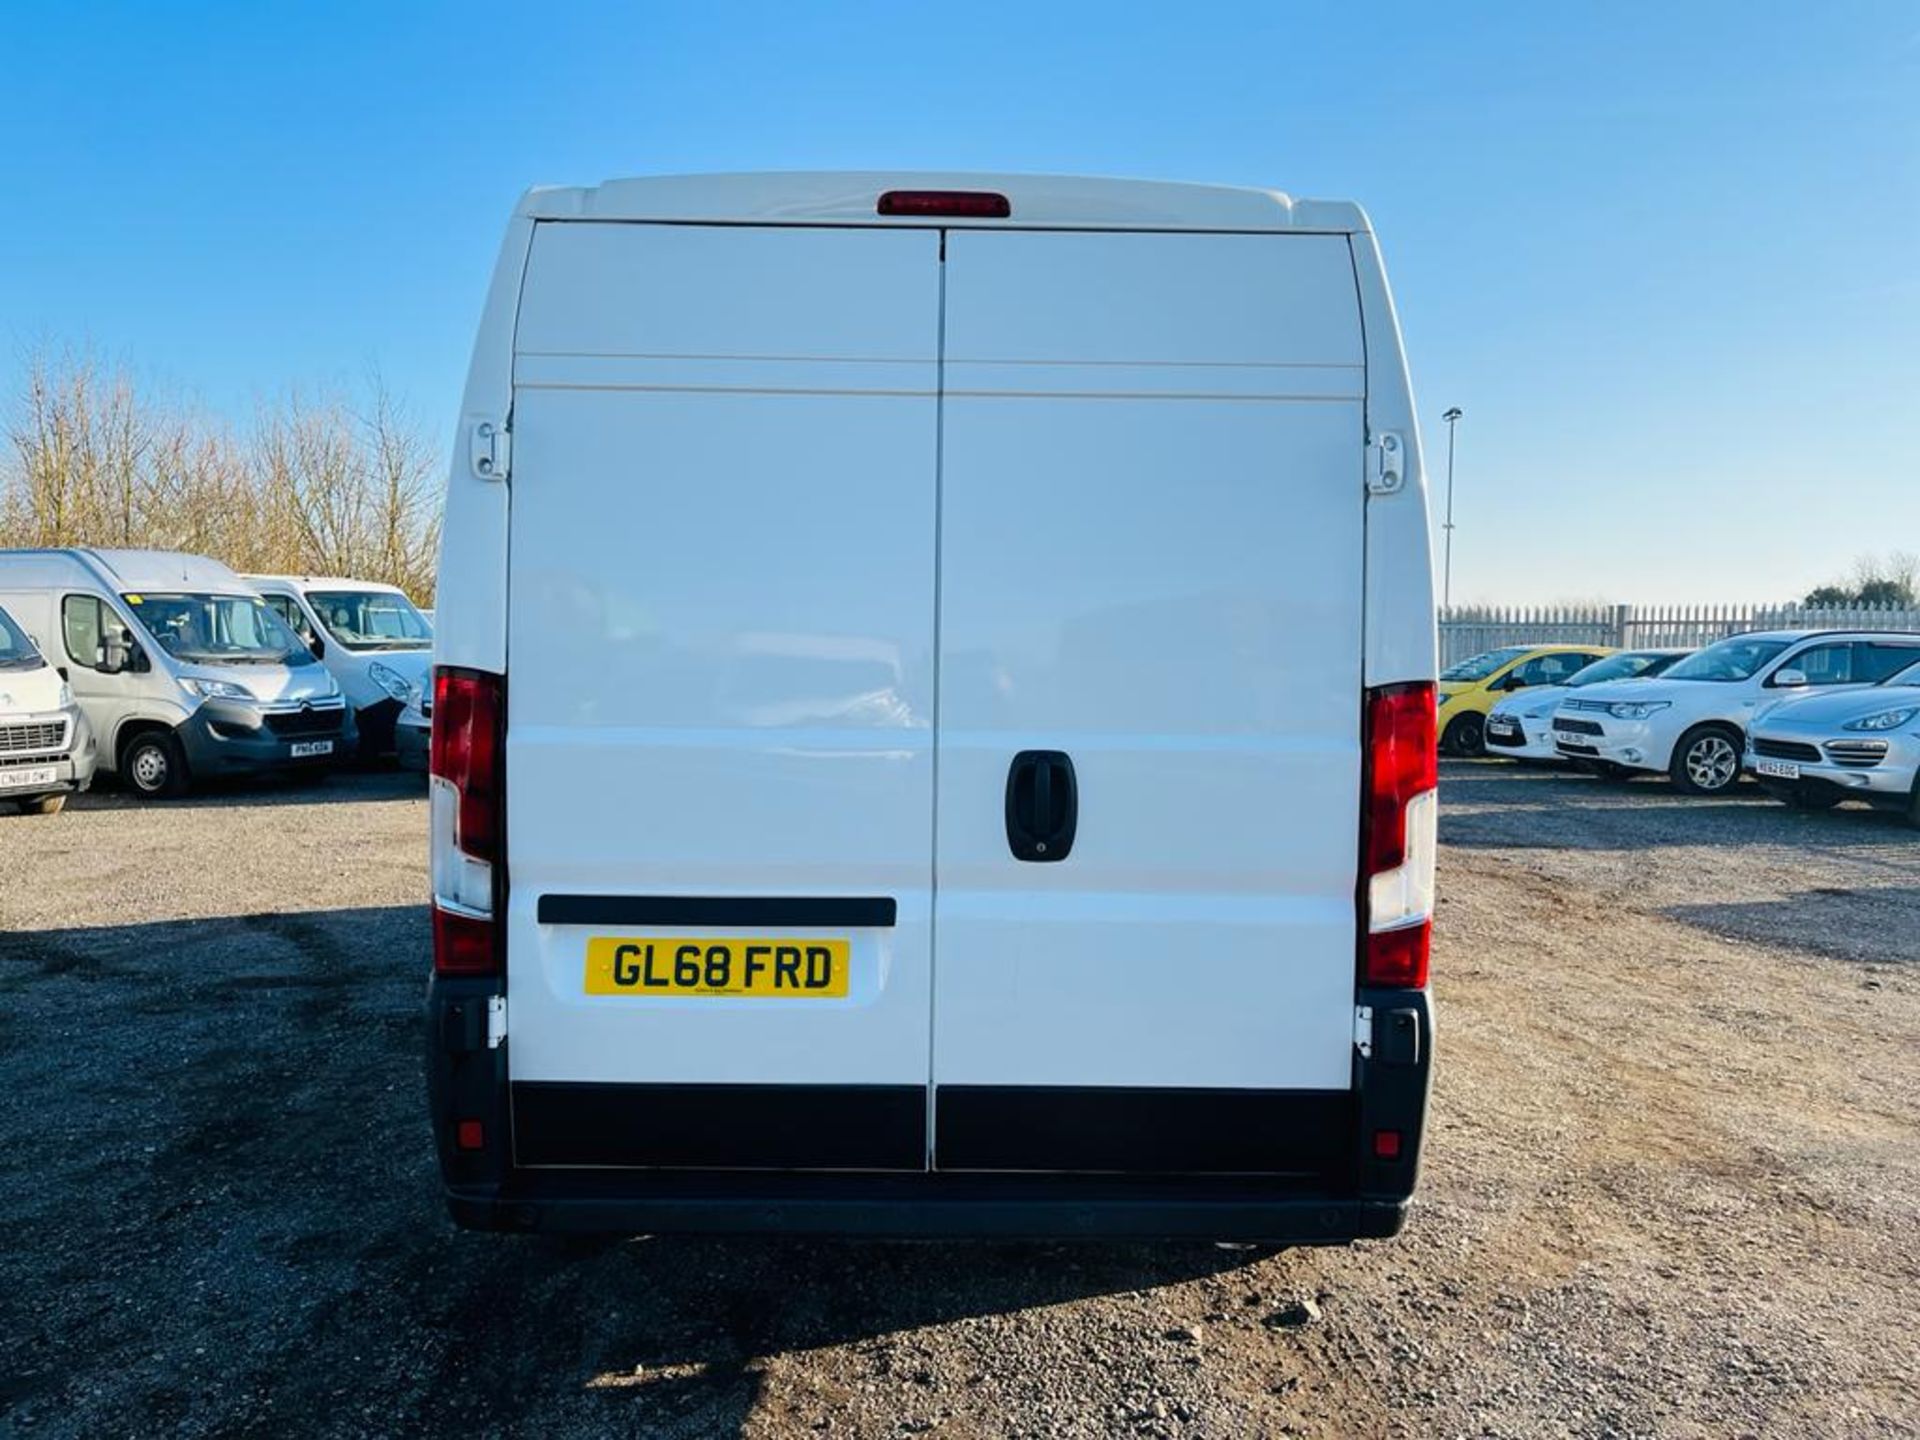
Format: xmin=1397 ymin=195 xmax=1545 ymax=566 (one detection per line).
xmin=428 ymin=979 xmax=1432 ymax=1244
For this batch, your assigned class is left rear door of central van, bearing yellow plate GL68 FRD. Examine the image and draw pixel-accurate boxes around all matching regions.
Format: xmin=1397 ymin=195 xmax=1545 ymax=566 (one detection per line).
xmin=507 ymin=223 xmax=939 ymax=1169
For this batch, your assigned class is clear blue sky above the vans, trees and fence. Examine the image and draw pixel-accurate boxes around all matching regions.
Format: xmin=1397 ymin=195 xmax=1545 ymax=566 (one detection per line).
xmin=0 ymin=0 xmax=1920 ymax=603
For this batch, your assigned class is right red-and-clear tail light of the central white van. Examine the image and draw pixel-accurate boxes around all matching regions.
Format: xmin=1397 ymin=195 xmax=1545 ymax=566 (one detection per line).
xmin=1359 ymin=682 xmax=1440 ymax=989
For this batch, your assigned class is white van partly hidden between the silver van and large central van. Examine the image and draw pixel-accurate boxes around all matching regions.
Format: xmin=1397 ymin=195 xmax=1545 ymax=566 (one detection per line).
xmin=246 ymin=574 xmax=434 ymax=756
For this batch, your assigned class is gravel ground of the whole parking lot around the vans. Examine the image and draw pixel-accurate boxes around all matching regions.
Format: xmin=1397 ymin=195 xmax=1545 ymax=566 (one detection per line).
xmin=0 ymin=762 xmax=1920 ymax=1438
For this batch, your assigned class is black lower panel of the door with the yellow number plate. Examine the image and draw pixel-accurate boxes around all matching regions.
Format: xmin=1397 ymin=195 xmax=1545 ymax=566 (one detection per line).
xmin=513 ymin=1081 xmax=927 ymax=1171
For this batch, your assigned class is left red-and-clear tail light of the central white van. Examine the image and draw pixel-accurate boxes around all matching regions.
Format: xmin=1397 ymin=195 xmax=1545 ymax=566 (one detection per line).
xmin=428 ymin=670 xmax=507 ymax=975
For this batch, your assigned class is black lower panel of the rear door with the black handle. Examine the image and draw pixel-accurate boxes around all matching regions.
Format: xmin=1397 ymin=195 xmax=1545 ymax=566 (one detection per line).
xmin=933 ymin=1085 xmax=1354 ymax=1179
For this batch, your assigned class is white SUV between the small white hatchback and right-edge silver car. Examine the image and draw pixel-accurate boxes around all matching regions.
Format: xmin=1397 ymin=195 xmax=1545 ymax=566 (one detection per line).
xmin=1553 ymin=630 xmax=1920 ymax=795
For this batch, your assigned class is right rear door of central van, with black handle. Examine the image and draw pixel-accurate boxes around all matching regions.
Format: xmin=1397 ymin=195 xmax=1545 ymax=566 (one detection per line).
xmin=933 ymin=230 xmax=1365 ymax=1173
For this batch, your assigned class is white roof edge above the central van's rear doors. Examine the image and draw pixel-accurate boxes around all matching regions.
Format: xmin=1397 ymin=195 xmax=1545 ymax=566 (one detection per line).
xmin=516 ymin=171 xmax=1371 ymax=234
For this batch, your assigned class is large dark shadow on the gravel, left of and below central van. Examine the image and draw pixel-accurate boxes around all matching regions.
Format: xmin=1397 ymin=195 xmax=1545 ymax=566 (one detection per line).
xmin=0 ymin=902 xmax=1258 ymax=1436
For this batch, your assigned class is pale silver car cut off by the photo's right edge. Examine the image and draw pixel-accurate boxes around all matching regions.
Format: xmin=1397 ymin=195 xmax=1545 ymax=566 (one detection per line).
xmin=1745 ymin=664 xmax=1920 ymax=828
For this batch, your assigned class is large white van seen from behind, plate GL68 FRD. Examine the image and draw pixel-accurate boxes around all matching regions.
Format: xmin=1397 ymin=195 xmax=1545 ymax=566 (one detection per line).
xmin=430 ymin=175 xmax=1436 ymax=1242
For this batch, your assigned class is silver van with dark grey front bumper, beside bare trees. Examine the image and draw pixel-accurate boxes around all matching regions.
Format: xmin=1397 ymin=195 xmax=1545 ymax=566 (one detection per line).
xmin=0 ymin=549 xmax=355 ymax=799
